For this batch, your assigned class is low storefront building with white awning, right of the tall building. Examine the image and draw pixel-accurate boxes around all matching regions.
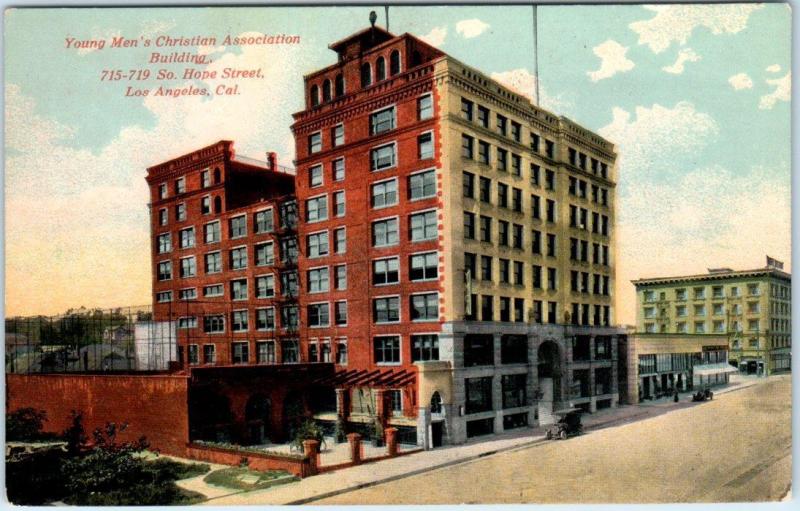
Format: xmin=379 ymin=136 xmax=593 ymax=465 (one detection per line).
xmin=627 ymin=333 xmax=737 ymax=404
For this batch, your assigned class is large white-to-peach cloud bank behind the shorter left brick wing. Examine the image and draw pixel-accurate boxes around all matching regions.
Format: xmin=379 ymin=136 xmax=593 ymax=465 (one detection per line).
xmin=5 ymin=33 xmax=313 ymax=314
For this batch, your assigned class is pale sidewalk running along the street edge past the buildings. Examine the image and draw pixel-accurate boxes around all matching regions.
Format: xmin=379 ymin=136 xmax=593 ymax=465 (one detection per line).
xmin=204 ymin=379 xmax=764 ymax=505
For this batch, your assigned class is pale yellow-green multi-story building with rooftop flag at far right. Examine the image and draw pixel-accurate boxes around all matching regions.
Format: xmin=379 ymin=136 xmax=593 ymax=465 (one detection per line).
xmin=633 ymin=258 xmax=792 ymax=375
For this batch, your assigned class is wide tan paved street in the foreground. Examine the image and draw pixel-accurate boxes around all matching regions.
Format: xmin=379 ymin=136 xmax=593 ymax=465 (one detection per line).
xmin=314 ymin=375 xmax=791 ymax=504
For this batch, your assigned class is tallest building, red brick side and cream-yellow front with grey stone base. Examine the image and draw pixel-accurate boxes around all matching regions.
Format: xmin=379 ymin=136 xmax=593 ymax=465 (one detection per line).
xmin=293 ymin=27 xmax=624 ymax=445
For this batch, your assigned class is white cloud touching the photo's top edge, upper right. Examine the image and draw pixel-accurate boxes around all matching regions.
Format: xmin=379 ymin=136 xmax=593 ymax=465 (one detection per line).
xmin=628 ymin=4 xmax=763 ymax=53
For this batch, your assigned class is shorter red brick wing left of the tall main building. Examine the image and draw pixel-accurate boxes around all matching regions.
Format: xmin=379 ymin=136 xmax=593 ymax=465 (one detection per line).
xmin=147 ymin=141 xmax=299 ymax=366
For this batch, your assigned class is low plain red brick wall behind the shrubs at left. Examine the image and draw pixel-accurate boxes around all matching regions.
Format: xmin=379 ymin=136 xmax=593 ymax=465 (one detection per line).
xmin=6 ymin=374 xmax=189 ymax=456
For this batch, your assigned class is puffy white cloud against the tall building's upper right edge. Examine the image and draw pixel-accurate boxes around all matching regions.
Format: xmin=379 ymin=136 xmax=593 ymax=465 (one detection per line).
xmin=598 ymin=101 xmax=719 ymax=181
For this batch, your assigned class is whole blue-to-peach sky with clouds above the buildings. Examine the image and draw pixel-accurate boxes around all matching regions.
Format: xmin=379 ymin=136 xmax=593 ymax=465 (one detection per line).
xmin=4 ymin=4 xmax=791 ymax=324
